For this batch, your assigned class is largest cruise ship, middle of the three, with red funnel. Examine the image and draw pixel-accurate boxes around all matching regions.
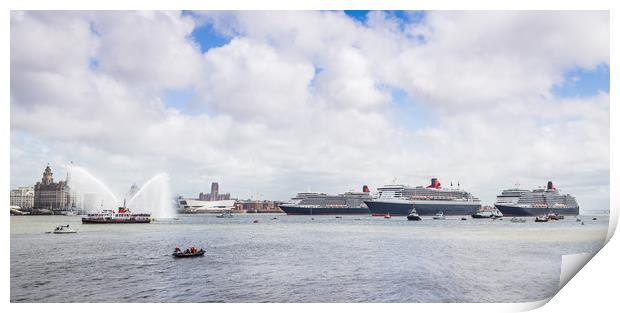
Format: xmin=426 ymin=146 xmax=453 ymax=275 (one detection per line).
xmin=364 ymin=178 xmax=481 ymax=215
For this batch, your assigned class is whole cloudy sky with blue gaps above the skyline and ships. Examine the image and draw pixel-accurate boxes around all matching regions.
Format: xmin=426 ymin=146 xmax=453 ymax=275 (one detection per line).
xmin=10 ymin=11 xmax=610 ymax=211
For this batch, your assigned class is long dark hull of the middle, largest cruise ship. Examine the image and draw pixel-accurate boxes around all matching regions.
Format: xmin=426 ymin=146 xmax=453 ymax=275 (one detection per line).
xmin=364 ymin=200 xmax=480 ymax=216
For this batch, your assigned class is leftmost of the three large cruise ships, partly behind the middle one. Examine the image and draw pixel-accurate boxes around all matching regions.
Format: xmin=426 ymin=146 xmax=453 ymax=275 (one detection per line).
xmin=280 ymin=186 xmax=372 ymax=215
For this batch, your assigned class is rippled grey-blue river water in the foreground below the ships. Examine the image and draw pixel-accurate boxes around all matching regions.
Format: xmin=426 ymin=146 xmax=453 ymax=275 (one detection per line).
xmin=10 ymin=214 xmax=608 ymax=302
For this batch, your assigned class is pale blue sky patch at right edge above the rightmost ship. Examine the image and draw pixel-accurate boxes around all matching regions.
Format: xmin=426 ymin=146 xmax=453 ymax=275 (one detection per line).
xmin=551 ymin=64 xmax=609 ymax=98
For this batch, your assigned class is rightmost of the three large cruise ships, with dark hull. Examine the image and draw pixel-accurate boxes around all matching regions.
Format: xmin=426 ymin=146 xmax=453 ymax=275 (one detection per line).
xmin=495 ymin=181 xmax=579 ymax=216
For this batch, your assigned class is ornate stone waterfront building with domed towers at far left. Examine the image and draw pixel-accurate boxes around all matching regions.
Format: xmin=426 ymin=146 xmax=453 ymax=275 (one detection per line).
xmin=33 ymin=164 xmax=74 ymax=211
